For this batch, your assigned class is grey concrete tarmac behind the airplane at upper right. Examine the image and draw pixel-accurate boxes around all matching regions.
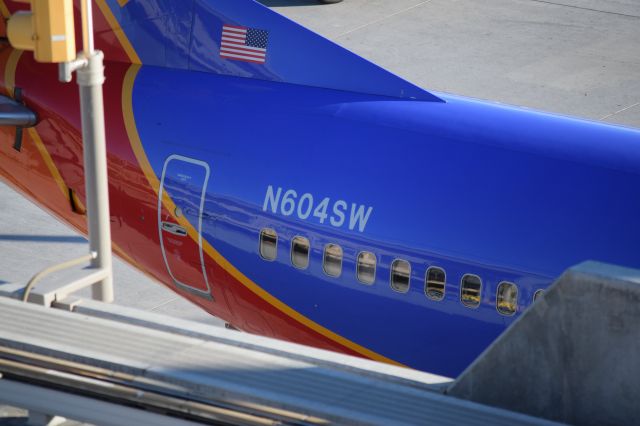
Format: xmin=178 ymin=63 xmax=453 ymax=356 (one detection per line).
xmin=261 ymin=0 xmax=640 ymax=127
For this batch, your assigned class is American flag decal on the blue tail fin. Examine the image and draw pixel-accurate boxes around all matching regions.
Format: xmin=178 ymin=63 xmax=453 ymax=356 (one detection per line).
xmin=220 ymin=25 xmax=269 ymax=64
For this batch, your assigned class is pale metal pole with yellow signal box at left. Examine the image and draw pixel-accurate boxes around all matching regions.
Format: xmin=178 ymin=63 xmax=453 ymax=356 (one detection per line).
xmin=5 ymin=0 xmax=113 ymax=302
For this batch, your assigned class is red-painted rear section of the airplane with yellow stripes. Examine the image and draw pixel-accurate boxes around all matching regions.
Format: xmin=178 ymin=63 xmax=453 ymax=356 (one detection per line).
xmin=0 ymin=0 xmax=390 ymax=364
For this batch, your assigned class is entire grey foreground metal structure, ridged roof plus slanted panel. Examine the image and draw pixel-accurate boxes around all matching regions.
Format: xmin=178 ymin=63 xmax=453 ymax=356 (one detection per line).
xmin=0 ymin=262 xmax=640 ymax=425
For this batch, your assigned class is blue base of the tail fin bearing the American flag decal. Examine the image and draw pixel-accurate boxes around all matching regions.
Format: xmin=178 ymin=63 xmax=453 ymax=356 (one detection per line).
xmin=97 ymin=0 xmax=442 ymax=102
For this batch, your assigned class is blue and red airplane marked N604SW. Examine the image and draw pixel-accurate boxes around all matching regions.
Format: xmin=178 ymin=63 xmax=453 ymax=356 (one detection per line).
xmin=0 ymin=0 xmax=640 ymax=377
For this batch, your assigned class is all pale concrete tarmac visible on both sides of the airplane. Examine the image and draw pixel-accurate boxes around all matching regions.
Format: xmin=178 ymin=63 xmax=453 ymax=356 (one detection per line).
xmin=0 ymin=0 xmax=640 ymax=325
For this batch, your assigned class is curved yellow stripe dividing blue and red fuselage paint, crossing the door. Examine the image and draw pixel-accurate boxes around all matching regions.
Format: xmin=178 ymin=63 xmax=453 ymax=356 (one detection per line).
xmin=122 ymin=65 xmax=402 ymax=365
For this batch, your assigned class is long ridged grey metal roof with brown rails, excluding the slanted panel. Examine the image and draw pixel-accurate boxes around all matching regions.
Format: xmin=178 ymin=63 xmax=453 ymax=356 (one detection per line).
xmin=0 ymin=297 xmax=549 ymax=425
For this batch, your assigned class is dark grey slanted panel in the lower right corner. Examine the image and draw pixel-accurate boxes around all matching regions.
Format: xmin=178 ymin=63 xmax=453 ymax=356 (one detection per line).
xmin=447 ymin=262 xmax=640 ymax=426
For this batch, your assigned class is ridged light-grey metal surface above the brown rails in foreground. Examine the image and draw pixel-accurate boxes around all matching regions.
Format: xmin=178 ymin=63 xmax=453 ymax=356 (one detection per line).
xmin=0 ymin=297 xmax=556 ymax=425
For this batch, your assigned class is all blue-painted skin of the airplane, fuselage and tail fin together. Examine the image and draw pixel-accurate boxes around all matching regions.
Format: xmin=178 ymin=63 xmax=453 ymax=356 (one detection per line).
xmin=2 ymin=0 xmax=640 ymax=377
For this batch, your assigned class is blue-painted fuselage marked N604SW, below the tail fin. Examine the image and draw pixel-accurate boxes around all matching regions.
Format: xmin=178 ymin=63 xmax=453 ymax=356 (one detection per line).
xmin=134 ymin=68 xmax=640 ymax=376
